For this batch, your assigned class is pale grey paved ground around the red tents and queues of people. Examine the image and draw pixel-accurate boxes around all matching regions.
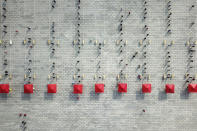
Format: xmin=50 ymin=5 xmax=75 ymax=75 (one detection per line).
xmin=0 ymin=0 xmax=197 ymax=131
